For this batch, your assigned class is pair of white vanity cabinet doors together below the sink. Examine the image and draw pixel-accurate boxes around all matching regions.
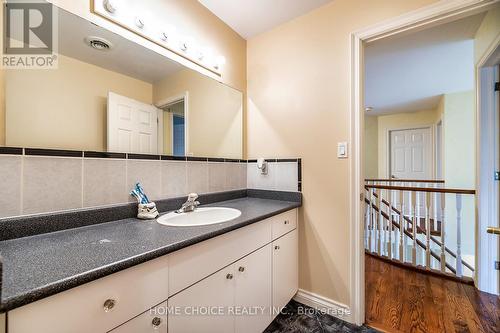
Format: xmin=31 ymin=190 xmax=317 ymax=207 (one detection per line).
xmin=168 ymin=244 xmax=272 ymax=333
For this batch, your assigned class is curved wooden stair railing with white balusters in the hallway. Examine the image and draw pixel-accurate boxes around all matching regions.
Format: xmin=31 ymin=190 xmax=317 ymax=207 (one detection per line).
xmin=364 ymin=183 xmax=475 ymax=280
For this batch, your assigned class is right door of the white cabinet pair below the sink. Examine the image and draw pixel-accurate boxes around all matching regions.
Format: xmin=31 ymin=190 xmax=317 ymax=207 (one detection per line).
xmin=234 ymin=244 xmax=272 ymax=333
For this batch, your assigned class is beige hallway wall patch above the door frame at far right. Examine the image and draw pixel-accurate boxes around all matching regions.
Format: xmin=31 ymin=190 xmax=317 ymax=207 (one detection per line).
xmin=474 ymin=4 xmax=500 ymax=64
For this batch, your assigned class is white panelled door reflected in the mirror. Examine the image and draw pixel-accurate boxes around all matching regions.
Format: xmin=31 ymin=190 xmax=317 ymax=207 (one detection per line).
xmin=108 ymin=92 xmax=159 ymax=154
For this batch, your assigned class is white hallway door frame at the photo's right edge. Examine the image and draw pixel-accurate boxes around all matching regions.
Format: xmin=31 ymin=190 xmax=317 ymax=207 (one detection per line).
xmin=475 ymin=40 xmax=500 ymax=295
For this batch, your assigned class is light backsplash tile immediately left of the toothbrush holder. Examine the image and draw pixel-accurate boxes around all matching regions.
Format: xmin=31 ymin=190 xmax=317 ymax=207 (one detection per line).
xmin=83 ymin=158 xmax=129 ymax=207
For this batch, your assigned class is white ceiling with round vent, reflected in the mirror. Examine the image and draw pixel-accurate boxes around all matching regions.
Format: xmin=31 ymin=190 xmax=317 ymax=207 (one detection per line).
xmin=58 ymin=9 xmax=184 ymax=83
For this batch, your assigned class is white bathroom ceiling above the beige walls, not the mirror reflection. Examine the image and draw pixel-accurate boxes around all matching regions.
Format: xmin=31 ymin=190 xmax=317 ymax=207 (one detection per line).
xmin=198 ymin=0 xmax=332 ymax=39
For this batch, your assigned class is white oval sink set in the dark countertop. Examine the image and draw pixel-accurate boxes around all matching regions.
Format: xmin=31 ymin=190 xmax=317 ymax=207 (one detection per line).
xmin=157 ymin=207 xmax=241 ymax=227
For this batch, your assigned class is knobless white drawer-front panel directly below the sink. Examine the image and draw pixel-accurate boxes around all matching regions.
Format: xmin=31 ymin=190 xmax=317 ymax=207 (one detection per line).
xmin=168 ymin=219 xmax=271 ymax=295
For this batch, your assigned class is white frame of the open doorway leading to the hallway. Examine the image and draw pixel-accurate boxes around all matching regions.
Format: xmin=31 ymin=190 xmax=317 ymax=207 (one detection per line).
xmin=349 ymin=0 xmax=498 ymax=325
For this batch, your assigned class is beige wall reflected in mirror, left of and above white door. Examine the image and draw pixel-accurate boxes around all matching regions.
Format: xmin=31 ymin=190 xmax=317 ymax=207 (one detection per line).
xmin=6 ymin=55 xmax=153 ymax=151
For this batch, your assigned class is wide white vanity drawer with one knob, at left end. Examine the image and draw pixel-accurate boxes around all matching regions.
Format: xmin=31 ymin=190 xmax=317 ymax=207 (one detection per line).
xmin=8 ymin=256 xmax=168 ymax=333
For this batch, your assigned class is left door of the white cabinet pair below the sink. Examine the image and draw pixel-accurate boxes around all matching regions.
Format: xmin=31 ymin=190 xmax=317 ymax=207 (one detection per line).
xmin=168 ymin=265 xmax=235 ymax=333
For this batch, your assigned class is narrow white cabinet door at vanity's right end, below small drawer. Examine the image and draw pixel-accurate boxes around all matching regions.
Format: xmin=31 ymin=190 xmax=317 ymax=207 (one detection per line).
xmin=273 ymin=229 xmax=299 ymax=316
